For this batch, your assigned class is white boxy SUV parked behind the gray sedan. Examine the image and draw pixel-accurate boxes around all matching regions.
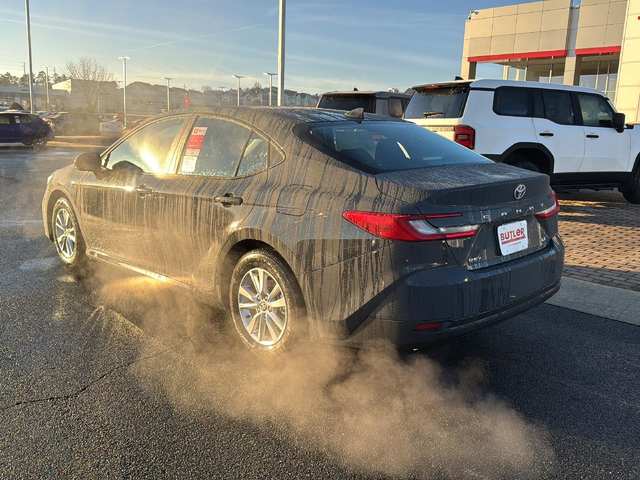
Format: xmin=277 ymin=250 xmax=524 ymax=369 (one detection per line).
xmin=404 ymin=80 xmax=640 ymax=203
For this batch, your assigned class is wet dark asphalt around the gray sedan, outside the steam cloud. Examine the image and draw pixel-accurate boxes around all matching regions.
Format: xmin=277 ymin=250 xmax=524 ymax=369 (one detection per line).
xmin=0 ymin=147 xmax=640 ymax=479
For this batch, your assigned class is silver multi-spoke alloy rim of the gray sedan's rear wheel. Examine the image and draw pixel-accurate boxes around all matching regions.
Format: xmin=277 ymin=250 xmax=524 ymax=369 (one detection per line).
xmin=238 ymin=268 xmax=287 ymax=346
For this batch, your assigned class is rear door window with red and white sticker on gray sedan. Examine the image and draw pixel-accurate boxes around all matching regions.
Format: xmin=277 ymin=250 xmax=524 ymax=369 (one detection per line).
xmin=179 ymin=117 xmax=251 ymax=177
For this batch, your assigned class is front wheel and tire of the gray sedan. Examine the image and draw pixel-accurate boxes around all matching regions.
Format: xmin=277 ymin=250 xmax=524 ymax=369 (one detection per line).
xmin=51 ymin=197 xmax=87 ymax=273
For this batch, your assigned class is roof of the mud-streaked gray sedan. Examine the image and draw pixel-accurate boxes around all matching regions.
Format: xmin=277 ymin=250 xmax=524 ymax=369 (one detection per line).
xmin=141 ymin=107 xmax=404 ymax=145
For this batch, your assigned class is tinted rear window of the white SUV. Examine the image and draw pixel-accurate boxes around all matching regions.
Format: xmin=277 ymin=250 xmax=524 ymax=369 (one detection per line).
xmin=404 ymin=85 xmax=469 ymax=118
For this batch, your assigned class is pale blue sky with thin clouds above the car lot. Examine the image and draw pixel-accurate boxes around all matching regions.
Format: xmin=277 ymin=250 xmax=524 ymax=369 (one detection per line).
xmin=0 ymin=0 xmax=540 ymax=93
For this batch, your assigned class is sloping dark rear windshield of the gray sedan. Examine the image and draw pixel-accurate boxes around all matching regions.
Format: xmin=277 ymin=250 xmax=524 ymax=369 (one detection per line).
xmin=295 ymin=121 xmax=491 ymax=175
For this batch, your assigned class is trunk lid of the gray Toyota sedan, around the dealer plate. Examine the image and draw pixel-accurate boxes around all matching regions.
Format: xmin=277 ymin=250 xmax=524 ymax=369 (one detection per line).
xmin=376 ymin=163 xmax=555 ymax=270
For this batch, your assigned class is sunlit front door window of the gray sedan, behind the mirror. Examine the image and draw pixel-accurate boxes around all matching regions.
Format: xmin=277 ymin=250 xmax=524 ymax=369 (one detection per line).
xmin=108 ymin=117 xmax=185 ymax=174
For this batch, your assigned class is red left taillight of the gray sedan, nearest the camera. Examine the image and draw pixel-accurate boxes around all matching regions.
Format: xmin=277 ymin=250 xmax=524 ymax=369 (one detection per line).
xmin=342 ymin=211 xmax=479 ymax=242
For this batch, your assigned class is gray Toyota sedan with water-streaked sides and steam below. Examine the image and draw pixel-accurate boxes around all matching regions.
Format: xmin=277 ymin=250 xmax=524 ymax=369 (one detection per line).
xmin=42 ymin=107 xmax=564 ymax=351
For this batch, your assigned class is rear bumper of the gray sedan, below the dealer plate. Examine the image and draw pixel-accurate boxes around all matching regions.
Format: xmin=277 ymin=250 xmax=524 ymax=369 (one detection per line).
xmin=322 ymin=236 xmax=564 ymax=347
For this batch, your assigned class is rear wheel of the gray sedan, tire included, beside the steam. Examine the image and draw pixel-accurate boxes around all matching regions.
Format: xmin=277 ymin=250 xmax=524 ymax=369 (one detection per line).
xmin=229 ymin=249 xmax=306 ymax=355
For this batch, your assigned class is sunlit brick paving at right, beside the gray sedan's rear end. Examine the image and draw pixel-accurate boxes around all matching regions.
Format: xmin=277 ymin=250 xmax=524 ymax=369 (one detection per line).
xmin=558 ymin=191 xmax=640 ymax=292
